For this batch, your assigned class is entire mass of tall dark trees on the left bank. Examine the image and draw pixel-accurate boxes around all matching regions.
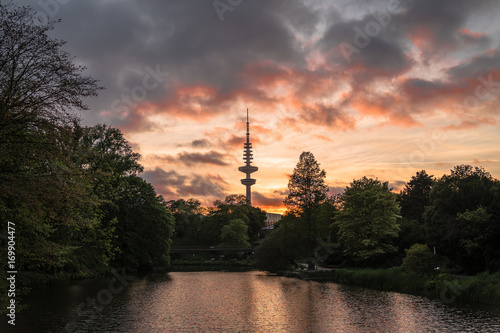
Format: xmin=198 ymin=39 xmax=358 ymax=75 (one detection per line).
xmin=0 ymin=1 xmax=174 ymax=309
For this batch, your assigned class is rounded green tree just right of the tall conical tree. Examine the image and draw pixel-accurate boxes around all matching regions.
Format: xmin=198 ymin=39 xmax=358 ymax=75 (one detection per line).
xmin=335 ymin=177 xmax=400 ymax=261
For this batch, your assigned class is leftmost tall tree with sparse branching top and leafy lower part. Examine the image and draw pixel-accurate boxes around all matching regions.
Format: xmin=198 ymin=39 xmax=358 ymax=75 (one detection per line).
xmin=0 ymin=0 xmax=103 ymax=290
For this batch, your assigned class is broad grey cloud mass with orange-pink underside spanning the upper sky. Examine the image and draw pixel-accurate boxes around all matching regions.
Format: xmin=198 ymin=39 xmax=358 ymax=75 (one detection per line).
xmin=21 ymin=0 xmax=498 ymax=132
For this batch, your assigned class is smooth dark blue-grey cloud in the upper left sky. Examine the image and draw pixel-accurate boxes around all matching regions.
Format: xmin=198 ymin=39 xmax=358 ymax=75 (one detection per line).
xmin=24 ymin=0 xmax=316 ymax=126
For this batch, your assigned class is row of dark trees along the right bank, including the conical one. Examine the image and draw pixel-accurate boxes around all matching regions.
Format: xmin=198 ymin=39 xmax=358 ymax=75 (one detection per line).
xmin=256 ymin=152 xmax=500 ymax=274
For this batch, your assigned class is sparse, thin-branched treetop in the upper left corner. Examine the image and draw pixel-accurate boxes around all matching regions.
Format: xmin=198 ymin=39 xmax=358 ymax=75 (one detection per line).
xmin=0 ymin=1 xmax=100 ymax=140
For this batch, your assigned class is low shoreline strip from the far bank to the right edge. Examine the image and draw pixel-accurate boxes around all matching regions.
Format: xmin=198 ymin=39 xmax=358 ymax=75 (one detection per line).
xmin=170 ymin=254 xmax=500 ymax=306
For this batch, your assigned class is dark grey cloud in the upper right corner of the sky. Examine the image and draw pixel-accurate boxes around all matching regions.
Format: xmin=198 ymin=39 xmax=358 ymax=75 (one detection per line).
xmin=319 ymin=0 xmax=497 ymax=74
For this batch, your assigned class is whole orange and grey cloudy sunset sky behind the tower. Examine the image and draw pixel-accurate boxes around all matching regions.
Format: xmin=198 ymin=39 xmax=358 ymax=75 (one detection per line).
xmin=19 ymin=0 xmax=500 ymax=212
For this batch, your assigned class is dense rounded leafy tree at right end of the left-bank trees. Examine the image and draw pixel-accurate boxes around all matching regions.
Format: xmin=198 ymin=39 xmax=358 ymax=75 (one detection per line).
xmin=75 ymin=125 xmax=174 ymax=270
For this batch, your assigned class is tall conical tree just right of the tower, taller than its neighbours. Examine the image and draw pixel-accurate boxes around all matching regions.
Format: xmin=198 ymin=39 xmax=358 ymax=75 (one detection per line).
xmin=284 ymin=152 xmax=328 ymax=254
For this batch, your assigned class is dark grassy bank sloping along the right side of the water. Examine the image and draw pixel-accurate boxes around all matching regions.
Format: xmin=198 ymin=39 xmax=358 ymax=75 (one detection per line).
xmin=278 ymin=267 xmax=500 ymax=305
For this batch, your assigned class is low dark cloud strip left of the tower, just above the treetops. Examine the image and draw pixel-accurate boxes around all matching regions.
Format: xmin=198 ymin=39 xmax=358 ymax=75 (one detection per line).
xmin=142 ymin=168 xmax=228 ymax=198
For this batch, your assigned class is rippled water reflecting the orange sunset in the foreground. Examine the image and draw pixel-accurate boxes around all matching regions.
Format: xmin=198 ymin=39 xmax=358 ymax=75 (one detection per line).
xmin=0 ymin=271 xmax=500 ymax=333
